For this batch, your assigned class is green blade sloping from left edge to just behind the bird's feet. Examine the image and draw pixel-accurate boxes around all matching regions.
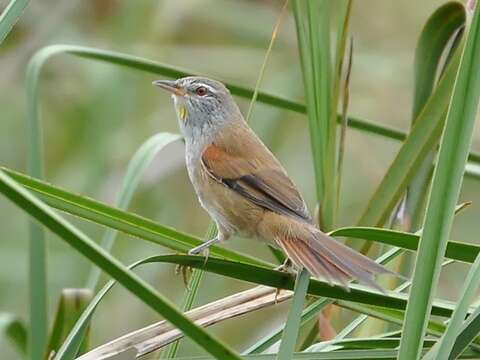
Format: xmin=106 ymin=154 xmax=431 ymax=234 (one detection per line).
xmin=0 ymin=168 xmax=273 ymax=266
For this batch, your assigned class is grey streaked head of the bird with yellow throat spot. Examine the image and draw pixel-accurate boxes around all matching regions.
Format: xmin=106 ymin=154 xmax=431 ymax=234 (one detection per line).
xmin=153 ymin=76 xmax=242 ymax=137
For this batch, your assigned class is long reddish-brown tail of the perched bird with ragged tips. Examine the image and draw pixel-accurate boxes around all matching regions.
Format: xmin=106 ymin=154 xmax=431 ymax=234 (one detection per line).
xmin=277 ymin=229 xmax=398 ymax=292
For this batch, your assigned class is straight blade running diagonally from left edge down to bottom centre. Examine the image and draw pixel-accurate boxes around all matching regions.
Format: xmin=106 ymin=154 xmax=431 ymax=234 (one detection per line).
xmin=0 ymin=171 xmax=239 ymax=359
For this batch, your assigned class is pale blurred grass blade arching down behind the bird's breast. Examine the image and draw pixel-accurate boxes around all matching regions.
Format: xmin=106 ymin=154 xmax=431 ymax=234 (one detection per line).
xmin=86 ymin=133 xmax=181 ymax=290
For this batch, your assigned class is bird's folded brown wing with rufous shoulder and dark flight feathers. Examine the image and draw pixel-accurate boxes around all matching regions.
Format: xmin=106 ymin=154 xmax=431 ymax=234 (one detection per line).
xmin=202 ymin=138 xmax=312 ymax=222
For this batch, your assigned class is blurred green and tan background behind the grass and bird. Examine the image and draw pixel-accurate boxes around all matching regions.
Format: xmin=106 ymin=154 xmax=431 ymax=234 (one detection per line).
xmin=0 ymin=0 xmax=480 ymax=359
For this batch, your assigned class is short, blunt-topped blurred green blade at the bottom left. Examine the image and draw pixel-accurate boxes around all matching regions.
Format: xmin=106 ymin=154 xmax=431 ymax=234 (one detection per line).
xmin=47 ymin=289 xmax=93 ymax=359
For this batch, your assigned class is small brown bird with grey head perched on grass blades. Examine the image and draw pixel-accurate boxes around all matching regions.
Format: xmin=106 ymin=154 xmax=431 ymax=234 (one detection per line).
xmin=153 ymin=77 xmax=394 ymax=289
